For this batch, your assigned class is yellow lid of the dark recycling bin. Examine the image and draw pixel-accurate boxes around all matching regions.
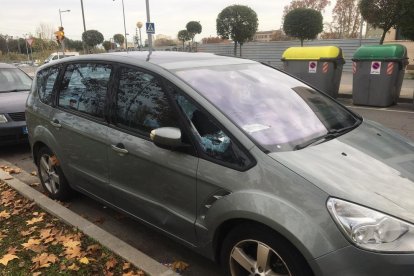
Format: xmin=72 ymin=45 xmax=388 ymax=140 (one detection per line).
xmin=282 ymin=46 xmax=343 ymax=60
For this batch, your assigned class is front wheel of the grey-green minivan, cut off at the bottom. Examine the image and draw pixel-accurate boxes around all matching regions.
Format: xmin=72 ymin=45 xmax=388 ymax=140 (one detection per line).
xmin=220 ymin=223 xmax=313 ymax=276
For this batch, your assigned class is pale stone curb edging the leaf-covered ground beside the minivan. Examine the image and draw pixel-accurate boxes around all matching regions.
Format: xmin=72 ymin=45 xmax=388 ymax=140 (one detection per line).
xmin=0 ymin=159 xmax=178 ymax=276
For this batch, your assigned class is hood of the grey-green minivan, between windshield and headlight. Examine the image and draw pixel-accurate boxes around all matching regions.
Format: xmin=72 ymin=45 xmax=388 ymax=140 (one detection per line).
xmin=269 ymin=121 xmax=414 ymax=223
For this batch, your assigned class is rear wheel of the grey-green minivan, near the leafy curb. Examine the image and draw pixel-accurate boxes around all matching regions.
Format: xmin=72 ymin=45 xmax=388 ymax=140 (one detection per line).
xmin=36 ymin=147 xmax=73 ymax=200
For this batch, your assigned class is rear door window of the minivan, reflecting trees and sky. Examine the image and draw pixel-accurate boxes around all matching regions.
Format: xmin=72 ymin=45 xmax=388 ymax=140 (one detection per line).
xmin=59 ymin=63 xmax=112 ymax=118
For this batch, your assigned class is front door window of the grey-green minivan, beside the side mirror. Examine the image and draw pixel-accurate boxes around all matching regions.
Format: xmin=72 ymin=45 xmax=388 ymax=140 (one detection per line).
xmin=116 ymin=68 xmax=177 ymax=134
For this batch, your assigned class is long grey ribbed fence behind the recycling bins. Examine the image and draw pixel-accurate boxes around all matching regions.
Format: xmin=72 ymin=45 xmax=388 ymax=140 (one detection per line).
xmin=198 ymin=39 xmax=379 ymax=71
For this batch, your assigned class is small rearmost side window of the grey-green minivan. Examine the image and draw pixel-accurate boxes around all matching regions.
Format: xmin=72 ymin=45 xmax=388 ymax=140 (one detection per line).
xmin=36 ymin=67 xmax=59 ymax=105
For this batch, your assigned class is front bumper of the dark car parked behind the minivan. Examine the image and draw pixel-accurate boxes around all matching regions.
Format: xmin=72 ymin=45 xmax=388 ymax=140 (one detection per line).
xmin=0 ymin=121 xmax=28 ymax=146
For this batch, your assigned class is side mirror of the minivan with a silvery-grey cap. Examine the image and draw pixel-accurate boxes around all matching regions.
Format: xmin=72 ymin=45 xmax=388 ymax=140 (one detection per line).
xmin=150 ymin=127 xmax=183 ymax=149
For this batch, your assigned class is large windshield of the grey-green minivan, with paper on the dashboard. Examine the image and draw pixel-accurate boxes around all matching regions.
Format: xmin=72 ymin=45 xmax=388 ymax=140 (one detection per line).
xmin=175 ymin=63 xmax=359 ymax=152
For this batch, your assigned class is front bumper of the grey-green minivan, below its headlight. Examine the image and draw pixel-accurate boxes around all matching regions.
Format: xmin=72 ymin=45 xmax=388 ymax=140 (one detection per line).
xmin=309 ymin=246 xmax=414 ymax=276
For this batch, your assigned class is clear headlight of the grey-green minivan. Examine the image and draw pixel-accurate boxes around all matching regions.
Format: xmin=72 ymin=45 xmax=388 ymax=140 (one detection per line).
xmin=327 ymin=198 xmax=414 ymax=252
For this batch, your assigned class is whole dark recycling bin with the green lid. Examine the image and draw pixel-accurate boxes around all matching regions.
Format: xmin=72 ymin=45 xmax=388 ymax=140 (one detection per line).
xmin=352 ymin=44 xmax=408 ymax=107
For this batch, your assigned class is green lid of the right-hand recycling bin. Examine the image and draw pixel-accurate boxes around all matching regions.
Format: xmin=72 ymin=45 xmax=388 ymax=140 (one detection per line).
xmin=353 ymin=44 xmax=407 ymax=60
